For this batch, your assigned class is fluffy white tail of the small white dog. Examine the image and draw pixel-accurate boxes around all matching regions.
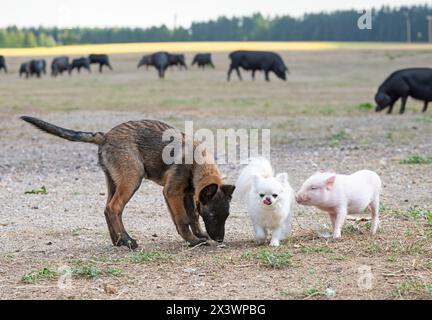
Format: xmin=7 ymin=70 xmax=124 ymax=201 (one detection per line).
xmin=233 ymin=157 xmax=274 ymax=201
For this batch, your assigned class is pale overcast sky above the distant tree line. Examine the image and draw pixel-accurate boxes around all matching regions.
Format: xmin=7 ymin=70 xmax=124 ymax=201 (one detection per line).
xmin=0 ymin=0 xmax=426 ymax=27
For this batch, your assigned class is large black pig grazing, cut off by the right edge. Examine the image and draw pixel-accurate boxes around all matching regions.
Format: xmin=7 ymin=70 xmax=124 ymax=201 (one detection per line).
xmin=375 ymin=68 xmax=432 ymax=114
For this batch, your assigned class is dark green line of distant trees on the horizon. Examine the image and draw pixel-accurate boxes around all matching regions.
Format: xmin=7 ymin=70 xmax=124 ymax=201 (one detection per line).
xmin=0 ymin=5 xmax=432 ymax=48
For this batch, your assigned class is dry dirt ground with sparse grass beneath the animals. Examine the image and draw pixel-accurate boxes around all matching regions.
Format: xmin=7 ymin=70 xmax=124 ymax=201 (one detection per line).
xmin=0 ymin=50 xmax=432 ymax=299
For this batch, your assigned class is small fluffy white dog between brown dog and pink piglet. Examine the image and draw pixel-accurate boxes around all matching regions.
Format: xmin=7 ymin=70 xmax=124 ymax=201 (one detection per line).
xmin=233 ymin=158 xmax=295 ymax=246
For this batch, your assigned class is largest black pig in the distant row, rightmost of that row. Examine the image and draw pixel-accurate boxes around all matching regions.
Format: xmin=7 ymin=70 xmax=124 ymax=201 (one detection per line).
xmin=228 ymin=51 xmax=288 ymax=81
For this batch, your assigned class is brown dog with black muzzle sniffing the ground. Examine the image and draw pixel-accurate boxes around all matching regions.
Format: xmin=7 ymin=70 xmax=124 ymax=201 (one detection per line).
xmin=21 ymin=116 xmax=234 ymax=249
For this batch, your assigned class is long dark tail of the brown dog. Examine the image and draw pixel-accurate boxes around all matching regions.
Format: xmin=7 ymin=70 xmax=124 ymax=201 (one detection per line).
xmin=20 ymin=116 xmax=105 ymax=144
